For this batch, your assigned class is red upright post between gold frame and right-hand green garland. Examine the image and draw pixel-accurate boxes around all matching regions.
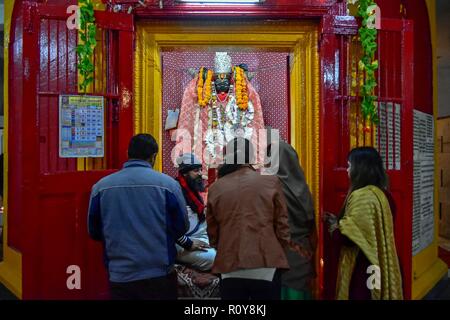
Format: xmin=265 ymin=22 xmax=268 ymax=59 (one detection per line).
xmin=319 ymin=10 xmax=357 ymax=299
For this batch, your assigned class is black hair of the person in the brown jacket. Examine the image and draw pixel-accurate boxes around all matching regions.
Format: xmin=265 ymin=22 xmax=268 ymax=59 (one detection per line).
xmin=218 ymin=137 xmax=254 ymax=178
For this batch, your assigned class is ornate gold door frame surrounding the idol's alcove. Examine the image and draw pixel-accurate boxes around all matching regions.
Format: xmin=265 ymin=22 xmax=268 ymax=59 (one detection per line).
xmin=134 ymin=20 xmax=320 ymax=266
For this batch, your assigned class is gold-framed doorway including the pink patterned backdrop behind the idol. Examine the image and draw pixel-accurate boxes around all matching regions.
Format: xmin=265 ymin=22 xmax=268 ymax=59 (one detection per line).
xmin=134 ymin=20 xmax=321 ymax=296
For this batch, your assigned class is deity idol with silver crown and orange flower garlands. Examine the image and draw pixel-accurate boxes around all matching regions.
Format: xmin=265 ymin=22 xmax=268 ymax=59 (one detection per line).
xmin=177 ymin=52 xmax=264 ymax=167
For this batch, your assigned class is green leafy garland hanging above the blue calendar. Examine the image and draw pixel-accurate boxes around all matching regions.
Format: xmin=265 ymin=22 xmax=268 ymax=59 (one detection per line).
xmin=77 ymin=0 xmax=97 ymax=93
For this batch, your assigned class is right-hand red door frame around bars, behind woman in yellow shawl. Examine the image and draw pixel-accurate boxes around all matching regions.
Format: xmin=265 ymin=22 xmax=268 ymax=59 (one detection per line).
xmin=321 ymin=17 xmax=414 ymax=299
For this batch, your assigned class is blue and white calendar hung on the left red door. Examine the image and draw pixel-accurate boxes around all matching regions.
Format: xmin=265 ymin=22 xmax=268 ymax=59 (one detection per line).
xmin=59 ymin=95 xmax=105 ymax=158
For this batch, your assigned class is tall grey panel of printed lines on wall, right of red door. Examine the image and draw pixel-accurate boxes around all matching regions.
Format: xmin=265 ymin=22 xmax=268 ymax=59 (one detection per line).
xmin=412 ymin=110 xmax=434 ymax=255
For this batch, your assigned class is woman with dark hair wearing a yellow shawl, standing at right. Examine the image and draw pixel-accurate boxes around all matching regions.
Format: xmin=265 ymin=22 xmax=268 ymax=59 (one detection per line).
xmin=325 ymin=147 xmax=403 ymax=300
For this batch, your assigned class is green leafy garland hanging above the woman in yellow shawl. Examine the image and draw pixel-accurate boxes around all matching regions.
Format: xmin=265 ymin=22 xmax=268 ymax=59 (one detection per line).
xmin=348 ymin=0 xmax=379 ymax=125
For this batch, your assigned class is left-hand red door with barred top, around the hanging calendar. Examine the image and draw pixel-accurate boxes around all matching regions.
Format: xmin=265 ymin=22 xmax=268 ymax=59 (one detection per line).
xmin=8 ymin=2 xmax=134 ymax=299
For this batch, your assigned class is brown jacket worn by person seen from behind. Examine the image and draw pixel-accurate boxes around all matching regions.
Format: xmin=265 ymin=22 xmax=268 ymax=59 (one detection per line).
xmin=206 ymin=166 xmax=290 ymax=273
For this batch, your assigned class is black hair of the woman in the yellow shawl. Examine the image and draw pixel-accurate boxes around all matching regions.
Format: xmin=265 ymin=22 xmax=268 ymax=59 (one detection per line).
xmin=348 ymin=147 xmax=388 ymax=191
